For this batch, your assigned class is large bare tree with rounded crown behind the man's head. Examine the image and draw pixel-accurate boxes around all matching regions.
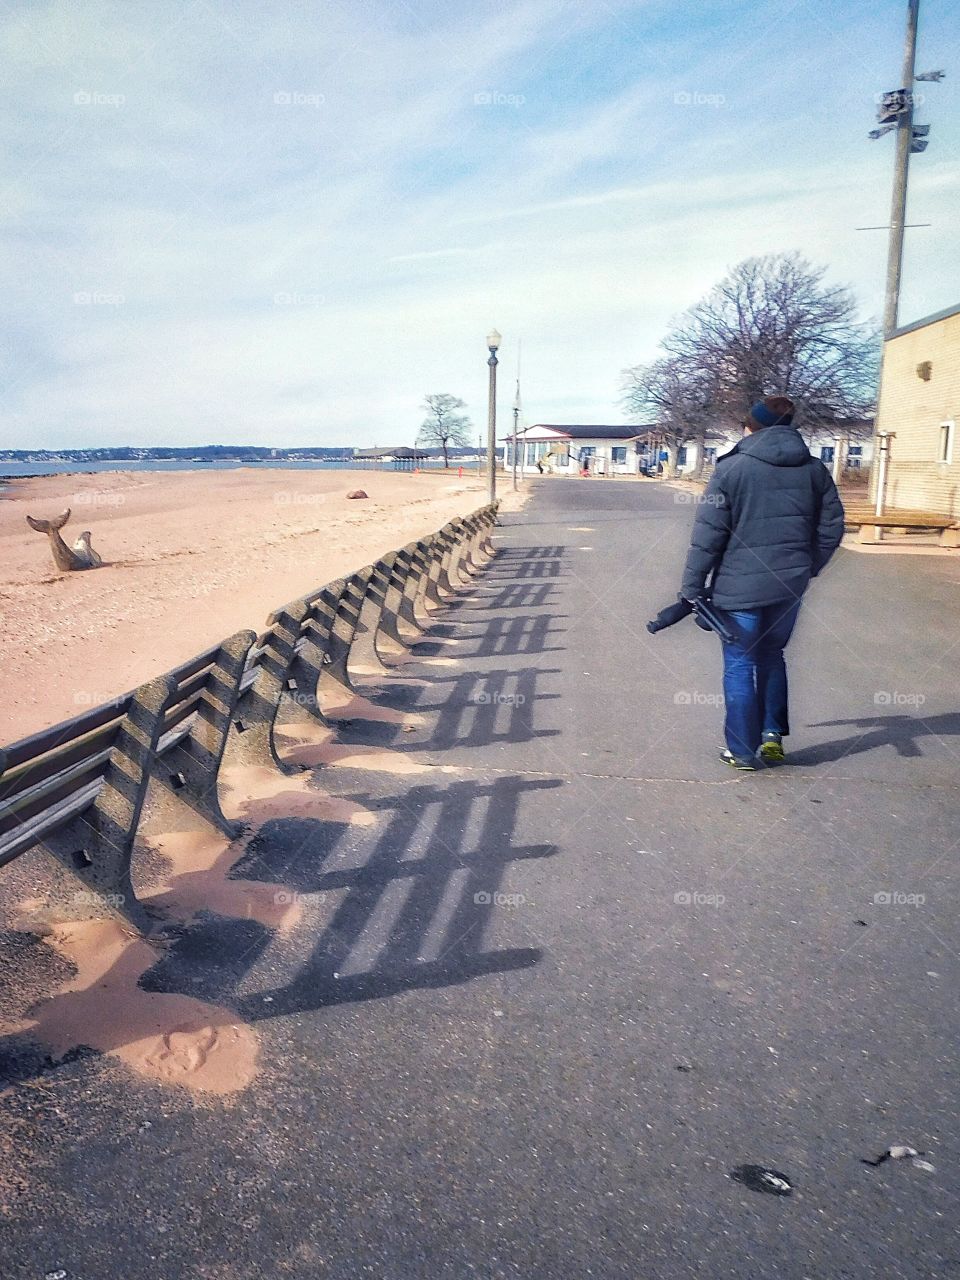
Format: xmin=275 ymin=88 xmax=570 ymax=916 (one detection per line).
xmin=625 ymin=253 xmax=879 ymax=471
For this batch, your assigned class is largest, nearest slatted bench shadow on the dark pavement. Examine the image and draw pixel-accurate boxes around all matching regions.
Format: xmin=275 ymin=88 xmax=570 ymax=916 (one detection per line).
xmin=133 ymin=777 xmax=562 ymax=1021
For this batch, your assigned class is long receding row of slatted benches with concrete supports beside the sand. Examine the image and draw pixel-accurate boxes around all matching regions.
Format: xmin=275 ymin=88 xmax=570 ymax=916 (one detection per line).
xmin=0 ymin=503 xmax=497 ymax=932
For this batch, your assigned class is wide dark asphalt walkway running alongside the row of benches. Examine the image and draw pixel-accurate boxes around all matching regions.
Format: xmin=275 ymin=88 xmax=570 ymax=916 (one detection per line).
xmin=0 ymin=480 xmax=960 ymax=1280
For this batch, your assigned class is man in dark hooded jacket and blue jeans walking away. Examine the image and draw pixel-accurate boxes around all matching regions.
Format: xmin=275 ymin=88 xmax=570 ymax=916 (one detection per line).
xmin=681 ymin=396 xmax=844 ymax=769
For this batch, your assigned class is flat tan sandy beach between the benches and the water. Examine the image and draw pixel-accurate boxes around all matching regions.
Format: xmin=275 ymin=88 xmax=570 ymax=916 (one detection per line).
xmin=0 ymin=467 xmax=512 ymax=744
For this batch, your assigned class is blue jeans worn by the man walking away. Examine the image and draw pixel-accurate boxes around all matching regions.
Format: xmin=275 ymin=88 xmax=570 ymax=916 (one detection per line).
xmin=723 ymin=600 xmax=800 ymax=758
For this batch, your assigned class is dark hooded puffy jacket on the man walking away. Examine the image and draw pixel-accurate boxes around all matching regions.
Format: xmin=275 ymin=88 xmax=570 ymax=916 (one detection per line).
xmin=681 ymin=426 xmax=844 ymax=609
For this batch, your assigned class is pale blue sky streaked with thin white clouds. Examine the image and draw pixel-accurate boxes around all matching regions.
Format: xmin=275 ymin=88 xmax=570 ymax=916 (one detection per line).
xmin=0 ymin=0 xmax=960 ymax=448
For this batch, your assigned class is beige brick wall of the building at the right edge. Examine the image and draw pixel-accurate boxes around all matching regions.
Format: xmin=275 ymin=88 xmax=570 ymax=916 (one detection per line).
xmin=874 ymin=307 xmax=960 ymax=517
